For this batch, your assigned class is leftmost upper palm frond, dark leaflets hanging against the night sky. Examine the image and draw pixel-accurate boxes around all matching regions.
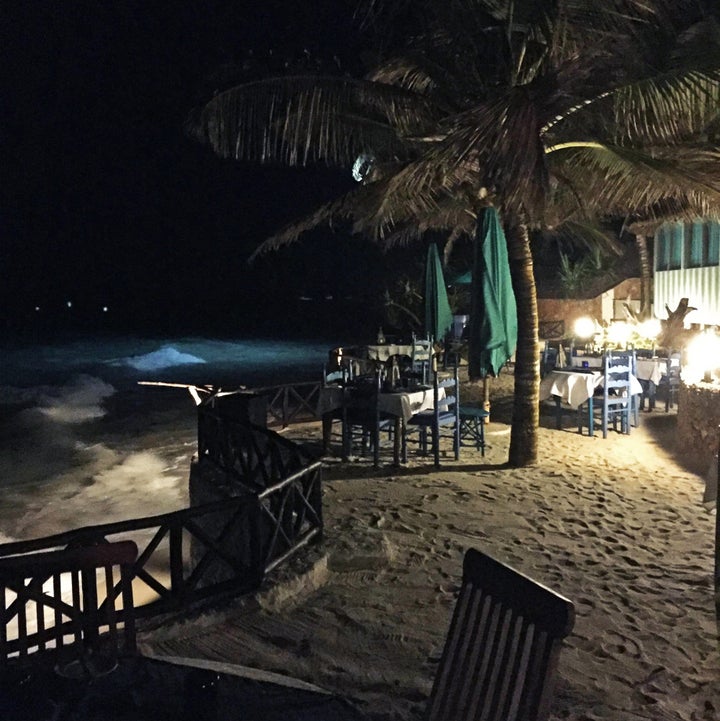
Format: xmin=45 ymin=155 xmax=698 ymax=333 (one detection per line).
xmin=189 ymin=76 xmax=437 ymax=165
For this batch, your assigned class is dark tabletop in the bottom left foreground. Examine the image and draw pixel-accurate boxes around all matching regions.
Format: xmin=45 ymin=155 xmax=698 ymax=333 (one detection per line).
xmin=0 ymin=655 xmax=366 ymax=721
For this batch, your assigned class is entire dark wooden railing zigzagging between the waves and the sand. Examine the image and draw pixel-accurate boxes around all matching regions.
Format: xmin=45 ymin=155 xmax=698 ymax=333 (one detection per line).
xmin=0 ymin=383 xmax=323 ymax=644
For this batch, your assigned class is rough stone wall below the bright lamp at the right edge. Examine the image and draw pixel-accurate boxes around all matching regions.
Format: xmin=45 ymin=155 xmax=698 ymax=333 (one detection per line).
xmin=677 ymin=383 xmax=720 ymax=476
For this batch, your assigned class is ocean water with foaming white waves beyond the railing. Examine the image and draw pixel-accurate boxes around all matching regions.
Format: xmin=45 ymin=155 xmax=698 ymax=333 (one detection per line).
xmin=0 ymin=336 xmax=333 ymax=542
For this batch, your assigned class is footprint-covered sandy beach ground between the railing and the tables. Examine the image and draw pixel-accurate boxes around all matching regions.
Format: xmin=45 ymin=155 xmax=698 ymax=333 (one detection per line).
xmin=141 ymin=374 xmax=720 ymax=721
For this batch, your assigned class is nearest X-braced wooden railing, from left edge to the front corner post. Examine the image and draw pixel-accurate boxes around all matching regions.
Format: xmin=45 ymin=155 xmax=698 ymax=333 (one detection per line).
xmin=0 ymin=461 xmax=322 ymax=628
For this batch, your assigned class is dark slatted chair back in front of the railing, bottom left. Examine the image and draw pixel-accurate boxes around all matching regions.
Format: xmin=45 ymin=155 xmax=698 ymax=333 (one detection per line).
xmin=0 ymin=541 xmax=138 ymax=667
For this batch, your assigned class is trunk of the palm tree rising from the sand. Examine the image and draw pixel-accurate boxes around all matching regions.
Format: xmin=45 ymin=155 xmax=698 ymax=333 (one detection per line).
xmin=505 ymin=217 xmax=540 ymax=468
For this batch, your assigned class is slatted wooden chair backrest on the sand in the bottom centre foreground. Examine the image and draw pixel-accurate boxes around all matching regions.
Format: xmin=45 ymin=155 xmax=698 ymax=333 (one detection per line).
xmin=425 ymin=549 xmax=575 ymax=721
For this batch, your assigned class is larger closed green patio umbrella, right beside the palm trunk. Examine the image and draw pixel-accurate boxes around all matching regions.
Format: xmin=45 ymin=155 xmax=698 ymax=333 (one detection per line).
xmin=468 ymin=208 xmax=517 ymax=382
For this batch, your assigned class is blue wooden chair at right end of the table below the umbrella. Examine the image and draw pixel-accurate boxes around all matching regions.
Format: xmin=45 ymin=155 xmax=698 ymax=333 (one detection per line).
xmin=402 ymin=366 xmax=460 ymax=468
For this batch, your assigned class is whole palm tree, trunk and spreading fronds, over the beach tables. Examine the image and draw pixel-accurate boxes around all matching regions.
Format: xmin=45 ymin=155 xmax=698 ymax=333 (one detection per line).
xmin=194 ymin=0 xmax=720 ymax=466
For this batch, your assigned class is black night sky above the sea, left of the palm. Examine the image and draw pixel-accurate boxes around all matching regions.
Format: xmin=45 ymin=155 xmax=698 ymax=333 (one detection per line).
xmin=0 ymin=0 xmax=396 ymax=332
